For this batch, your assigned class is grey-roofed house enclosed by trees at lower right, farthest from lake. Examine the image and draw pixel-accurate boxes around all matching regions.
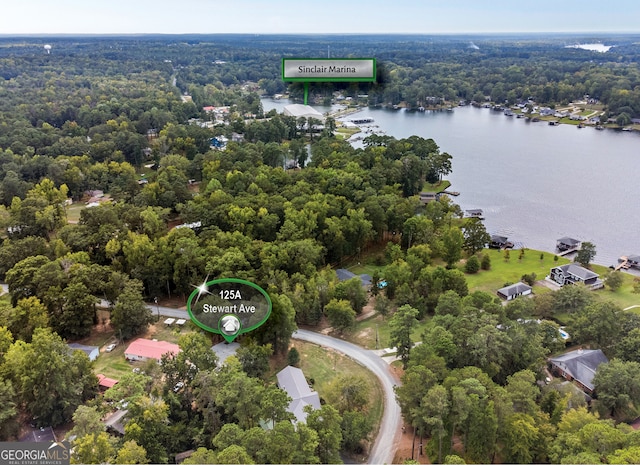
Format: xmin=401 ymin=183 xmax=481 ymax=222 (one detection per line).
xmin=549 ymin=349 xmax=609 ymax=395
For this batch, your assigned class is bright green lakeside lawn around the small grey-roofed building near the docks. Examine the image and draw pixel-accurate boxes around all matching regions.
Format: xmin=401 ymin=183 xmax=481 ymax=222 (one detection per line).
xmin=461 ymin=249 xmax=570 ymax=294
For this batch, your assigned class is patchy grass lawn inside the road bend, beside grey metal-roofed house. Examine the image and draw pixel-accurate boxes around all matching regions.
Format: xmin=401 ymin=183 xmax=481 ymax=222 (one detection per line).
xmin=293 ymin=341 xmax=384 ymax=436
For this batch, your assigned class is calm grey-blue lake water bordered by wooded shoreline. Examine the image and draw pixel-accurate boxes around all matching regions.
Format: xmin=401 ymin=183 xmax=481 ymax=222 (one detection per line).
xmin=263 ymin=99 xmax=640 ymax=266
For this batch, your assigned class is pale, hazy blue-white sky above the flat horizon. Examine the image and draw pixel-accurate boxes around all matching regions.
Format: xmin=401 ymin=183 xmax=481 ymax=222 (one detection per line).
xmin=0 ymin=0 xmax=640 ymax=35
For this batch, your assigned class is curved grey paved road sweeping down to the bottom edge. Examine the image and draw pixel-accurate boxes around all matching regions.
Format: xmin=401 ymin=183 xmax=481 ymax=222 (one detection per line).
xmin=292 ymin=329 xmax=401 ymax=464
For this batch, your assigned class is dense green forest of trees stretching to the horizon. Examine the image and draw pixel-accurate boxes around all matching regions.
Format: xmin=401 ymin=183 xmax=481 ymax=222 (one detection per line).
xmin=0 ymin=36 xmax=640 ymax=463
